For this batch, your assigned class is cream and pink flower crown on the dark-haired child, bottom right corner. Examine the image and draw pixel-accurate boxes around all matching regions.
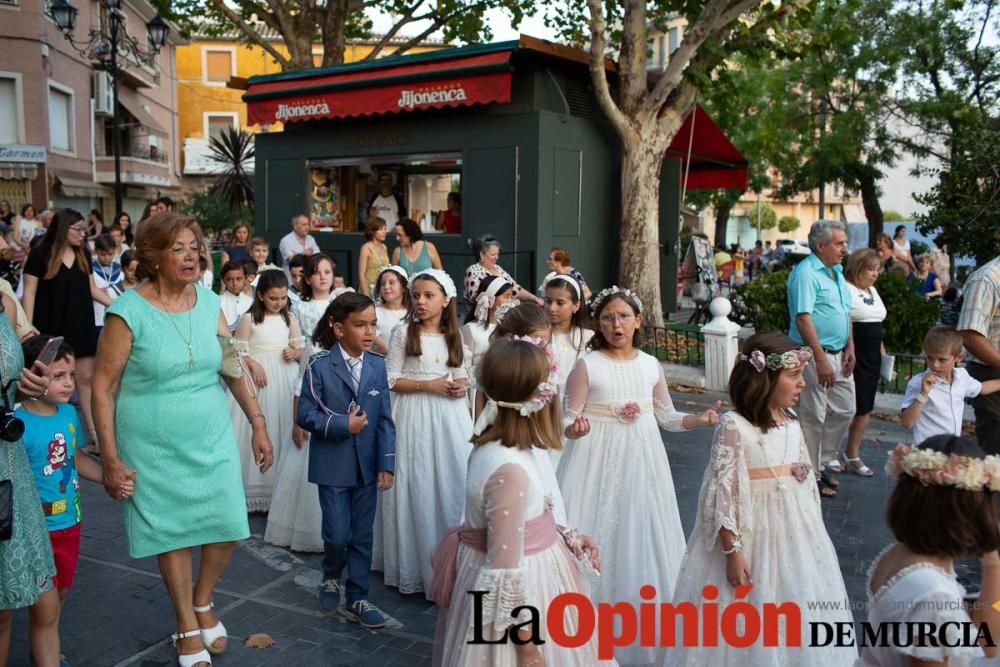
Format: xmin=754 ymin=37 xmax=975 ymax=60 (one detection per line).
xmin=885 ymin=445 xmax=1000 ymax=491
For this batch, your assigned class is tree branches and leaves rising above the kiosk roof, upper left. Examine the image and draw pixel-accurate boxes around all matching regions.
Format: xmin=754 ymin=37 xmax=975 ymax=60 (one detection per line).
xmin=152 ymin=0 xmax=535 ymax=70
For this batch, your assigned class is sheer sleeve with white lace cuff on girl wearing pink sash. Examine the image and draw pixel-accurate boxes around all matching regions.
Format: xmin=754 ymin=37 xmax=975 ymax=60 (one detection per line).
xmin=474 ymin=463 xmax=538 ymax=632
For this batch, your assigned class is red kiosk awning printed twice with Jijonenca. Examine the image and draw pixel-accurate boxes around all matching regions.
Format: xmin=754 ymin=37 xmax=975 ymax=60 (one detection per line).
xmin=243 ymin=49 xmax=513 ymax=125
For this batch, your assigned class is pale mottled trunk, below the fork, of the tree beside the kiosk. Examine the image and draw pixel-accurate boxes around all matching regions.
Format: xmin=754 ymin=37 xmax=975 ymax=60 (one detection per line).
xmin=618 ymin=136 xmax=664 ymax=327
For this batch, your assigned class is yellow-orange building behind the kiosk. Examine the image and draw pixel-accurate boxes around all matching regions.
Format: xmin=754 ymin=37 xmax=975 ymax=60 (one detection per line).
xmin=176 ymin=28 xmax=447 ymax=191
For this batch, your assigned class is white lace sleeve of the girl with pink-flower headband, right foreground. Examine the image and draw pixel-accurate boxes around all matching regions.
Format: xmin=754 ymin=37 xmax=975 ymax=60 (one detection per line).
xmin=699 ymin=414 xmax=751 ymax=550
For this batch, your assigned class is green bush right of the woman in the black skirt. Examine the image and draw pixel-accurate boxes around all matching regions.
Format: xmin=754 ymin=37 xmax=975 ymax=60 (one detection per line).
xmin=875 ymin=270 xmax=941 ymax=354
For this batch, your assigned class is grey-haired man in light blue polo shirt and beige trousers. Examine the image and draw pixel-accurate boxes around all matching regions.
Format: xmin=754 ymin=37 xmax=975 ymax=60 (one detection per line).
xmin=788 ymin=220 xmax=855 ymax=496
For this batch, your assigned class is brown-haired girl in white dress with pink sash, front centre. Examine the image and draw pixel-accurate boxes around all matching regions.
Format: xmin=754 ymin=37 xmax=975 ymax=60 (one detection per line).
xmin=431 ymin=340 xmax=600 ymax=667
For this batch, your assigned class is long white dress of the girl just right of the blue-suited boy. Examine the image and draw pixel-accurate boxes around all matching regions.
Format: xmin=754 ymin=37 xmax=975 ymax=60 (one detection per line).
xmin=372 ymin=326 xmax=472 ymax=593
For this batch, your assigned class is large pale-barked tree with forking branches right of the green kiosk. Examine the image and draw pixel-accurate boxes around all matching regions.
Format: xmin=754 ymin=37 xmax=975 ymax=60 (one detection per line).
xmin=550 ymin=0 xmax=799 ymax=325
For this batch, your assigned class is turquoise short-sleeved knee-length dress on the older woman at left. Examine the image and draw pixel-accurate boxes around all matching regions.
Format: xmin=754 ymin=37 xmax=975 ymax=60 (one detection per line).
xmin=108 ymin=286 xmax=250 ymax=558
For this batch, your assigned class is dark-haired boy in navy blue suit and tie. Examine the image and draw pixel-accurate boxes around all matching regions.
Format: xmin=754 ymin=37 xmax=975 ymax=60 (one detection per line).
xmin=296 ymin=292 xmax=396 ymax=628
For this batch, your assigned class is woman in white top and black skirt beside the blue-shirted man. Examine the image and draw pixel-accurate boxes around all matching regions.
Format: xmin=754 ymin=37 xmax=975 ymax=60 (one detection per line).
xmin=844 ymin=248 xmax=886 ymax=477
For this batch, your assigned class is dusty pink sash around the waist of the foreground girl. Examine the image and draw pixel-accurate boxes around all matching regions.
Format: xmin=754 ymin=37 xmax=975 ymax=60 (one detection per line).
xmin=428 ymin=509 xmax=575 ymax=607
